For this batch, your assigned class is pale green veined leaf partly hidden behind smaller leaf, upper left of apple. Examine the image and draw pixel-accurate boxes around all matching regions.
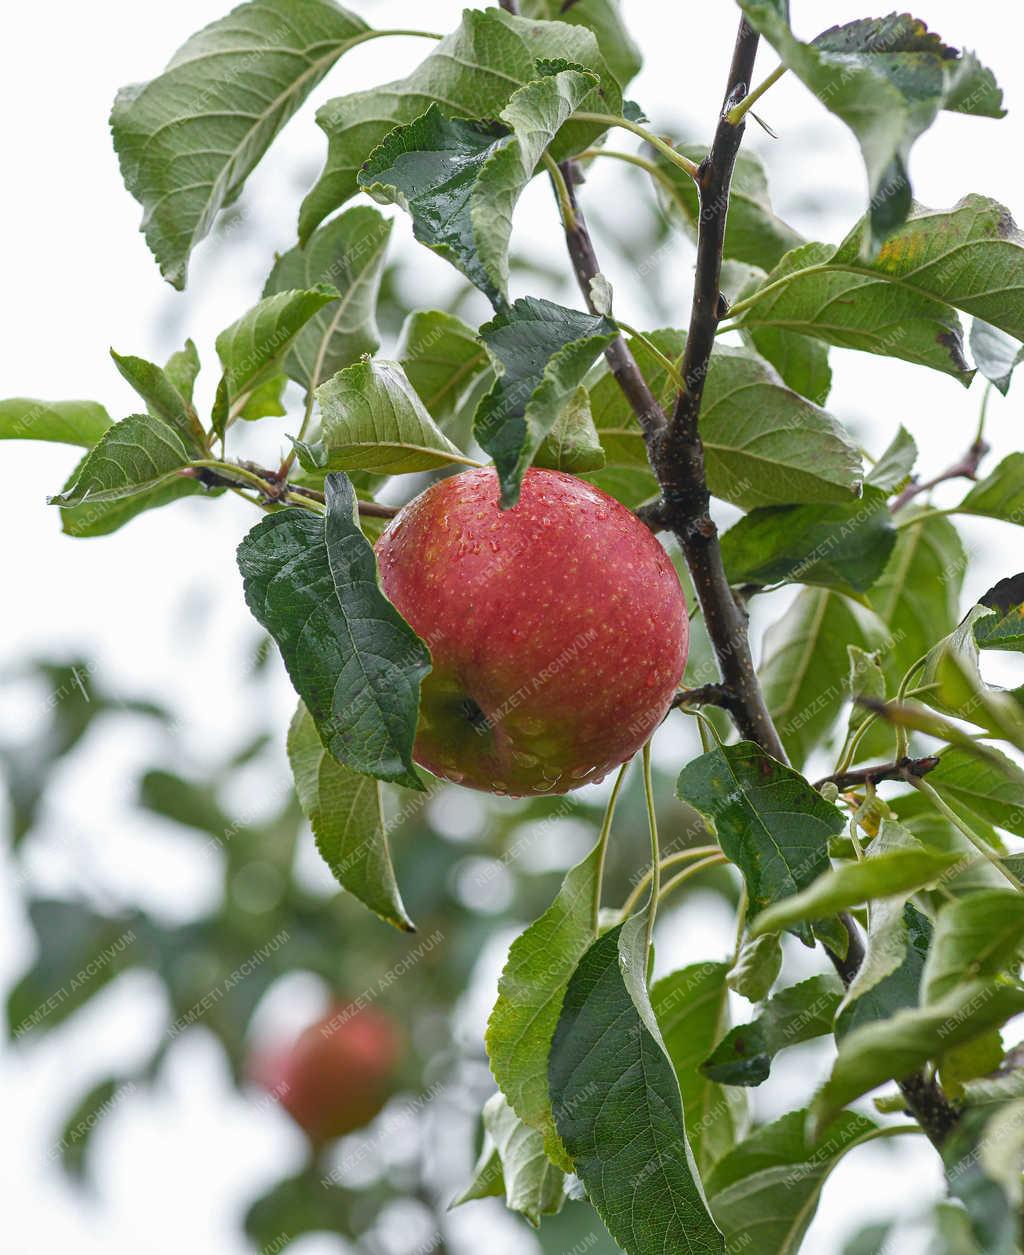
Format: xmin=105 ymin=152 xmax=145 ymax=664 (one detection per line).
xmin=264 ymin=205 xmax=392 ymax=392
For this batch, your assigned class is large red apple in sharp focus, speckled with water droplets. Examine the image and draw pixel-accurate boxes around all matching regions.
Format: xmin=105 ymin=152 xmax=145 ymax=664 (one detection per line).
xmin=376 ymin=468 xmax=689 ymax=797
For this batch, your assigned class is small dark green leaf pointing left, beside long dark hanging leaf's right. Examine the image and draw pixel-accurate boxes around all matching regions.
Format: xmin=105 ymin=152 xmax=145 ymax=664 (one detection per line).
xmin=700 ymin=976 xmax=842 ymax=1086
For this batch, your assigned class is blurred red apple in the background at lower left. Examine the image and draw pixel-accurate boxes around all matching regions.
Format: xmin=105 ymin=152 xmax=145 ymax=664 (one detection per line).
xmin=252 ymin=1004 xmax=399 ymax=1145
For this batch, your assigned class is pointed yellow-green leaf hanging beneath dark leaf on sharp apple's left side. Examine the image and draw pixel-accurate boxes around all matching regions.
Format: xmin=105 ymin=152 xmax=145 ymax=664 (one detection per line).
xmin=287 ymin=703 xmax=414 ymax=932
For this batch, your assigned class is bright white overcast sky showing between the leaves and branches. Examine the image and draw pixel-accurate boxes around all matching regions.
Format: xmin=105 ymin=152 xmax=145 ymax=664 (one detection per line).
xmin=0 ymin=0 xmax=1024 ymax=1255
